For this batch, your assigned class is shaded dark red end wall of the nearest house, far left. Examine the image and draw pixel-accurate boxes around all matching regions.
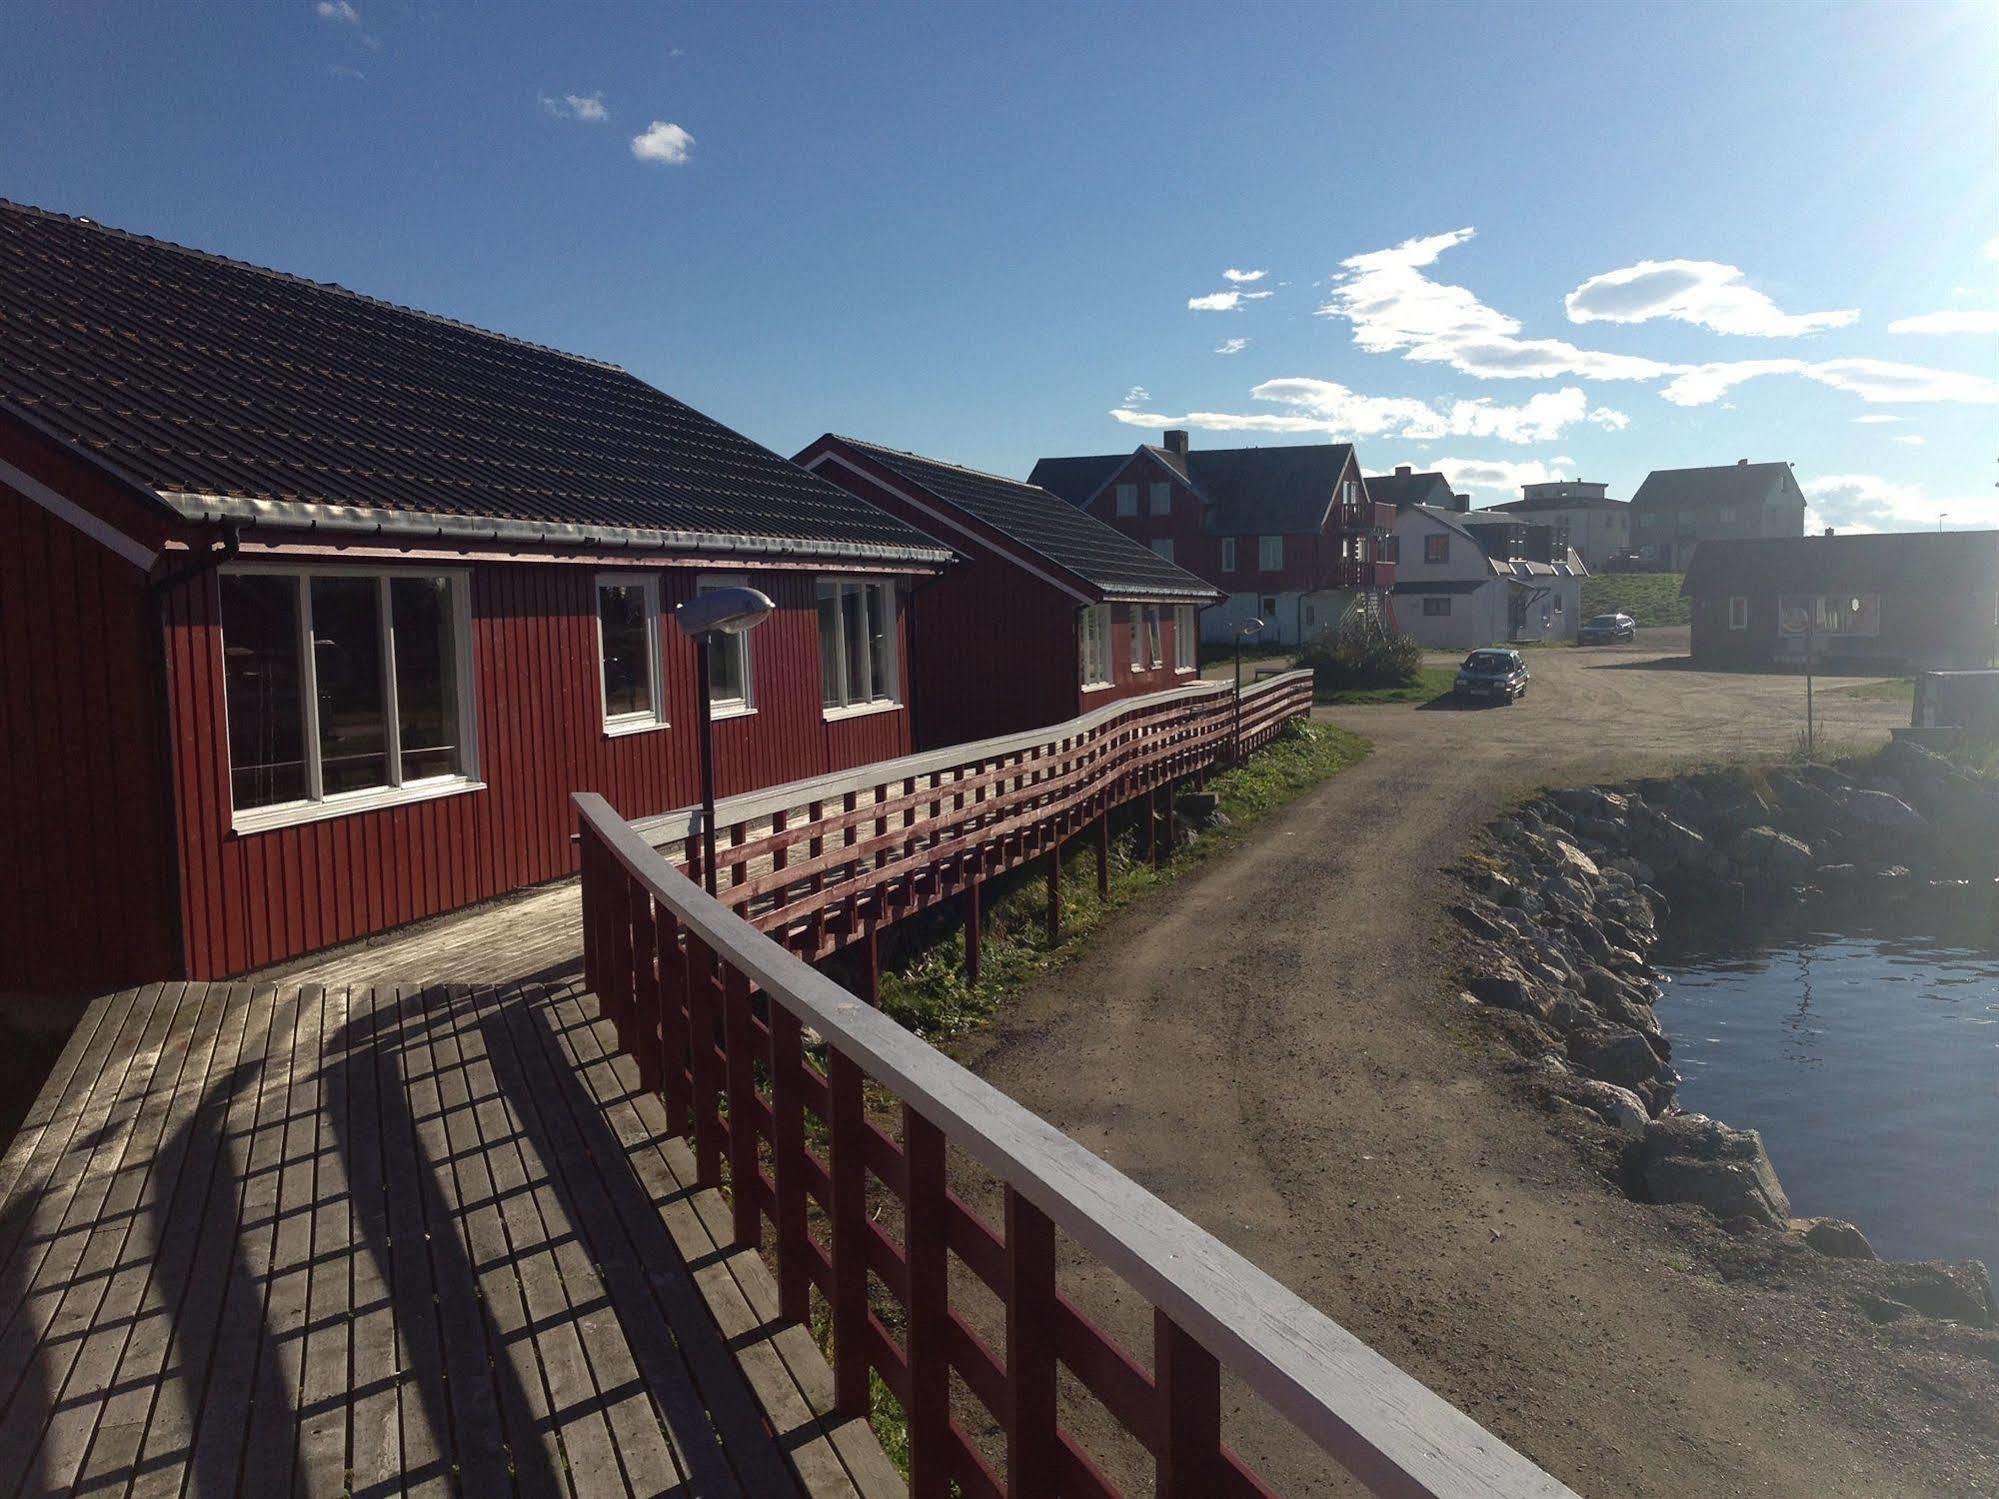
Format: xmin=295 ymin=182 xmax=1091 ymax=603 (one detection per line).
xmin=0 ymin=486 xmax=178 ymax=993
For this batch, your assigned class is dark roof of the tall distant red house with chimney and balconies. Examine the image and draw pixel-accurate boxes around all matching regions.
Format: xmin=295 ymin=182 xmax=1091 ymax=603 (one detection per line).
xmin=1027 ymin=442 xmax=1371 ymax=536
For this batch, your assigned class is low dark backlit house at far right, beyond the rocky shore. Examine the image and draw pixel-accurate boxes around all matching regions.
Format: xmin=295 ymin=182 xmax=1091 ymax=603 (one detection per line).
xmin=1681 ymin=532 xmax=1999 ymax=672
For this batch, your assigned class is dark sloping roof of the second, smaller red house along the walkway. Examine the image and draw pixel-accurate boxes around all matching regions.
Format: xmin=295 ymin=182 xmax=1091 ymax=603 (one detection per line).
xmin=834 ymin=436 xmax=1221 ymax=600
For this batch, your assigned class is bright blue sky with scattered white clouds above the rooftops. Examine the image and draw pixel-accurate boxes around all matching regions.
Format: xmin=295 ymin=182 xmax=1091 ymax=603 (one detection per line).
xmin=11 ymin=0 xmax=1999 ymax=530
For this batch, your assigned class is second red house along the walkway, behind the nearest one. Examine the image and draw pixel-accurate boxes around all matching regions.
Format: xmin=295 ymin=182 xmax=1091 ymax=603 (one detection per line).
xmin=796 ymin=434 xmax=1221 ymax=750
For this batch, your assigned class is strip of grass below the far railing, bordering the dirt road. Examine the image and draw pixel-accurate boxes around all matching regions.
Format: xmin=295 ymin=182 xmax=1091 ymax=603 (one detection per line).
xmin=863 ymin=722 xmax=1367 ymax=1039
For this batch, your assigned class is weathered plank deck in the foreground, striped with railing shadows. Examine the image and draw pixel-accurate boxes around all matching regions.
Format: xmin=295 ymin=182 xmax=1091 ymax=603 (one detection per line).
xmin=0 ymin=983 xmax=902 ymax=1499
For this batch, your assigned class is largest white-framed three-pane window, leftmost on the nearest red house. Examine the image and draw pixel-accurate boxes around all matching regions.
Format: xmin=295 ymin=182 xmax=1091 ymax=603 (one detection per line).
xmin=220 ymin=564 xmax=478 ymax=833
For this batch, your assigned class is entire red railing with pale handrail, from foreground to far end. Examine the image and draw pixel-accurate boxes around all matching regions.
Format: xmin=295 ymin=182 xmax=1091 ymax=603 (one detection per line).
xmin=576 ymin=674 xmax=1567 ymax=1499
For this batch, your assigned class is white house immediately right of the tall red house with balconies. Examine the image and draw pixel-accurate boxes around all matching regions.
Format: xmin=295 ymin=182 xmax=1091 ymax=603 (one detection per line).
xmin=1395 ymin=506 xmax=1589 ymax=650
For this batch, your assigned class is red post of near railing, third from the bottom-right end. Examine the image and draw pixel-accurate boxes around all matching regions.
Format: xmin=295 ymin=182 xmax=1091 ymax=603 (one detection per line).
xmin=902 ymin=1103 xmax=952 ymax=1499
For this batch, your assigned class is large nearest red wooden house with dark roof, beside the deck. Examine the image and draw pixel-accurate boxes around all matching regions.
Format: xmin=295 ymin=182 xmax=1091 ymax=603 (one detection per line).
xmin=0 ymin=204 xmax=950 ymax=991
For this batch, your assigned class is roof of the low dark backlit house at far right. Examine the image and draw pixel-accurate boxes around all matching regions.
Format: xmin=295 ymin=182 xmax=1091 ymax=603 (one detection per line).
xmin=1679 ymin=532 xmax=1999 ymax=598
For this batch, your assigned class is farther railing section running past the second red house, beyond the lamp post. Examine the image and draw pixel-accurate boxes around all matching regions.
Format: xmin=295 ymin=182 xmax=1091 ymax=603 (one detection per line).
xmin=638 ymin=672 xmax=1311 ymax=979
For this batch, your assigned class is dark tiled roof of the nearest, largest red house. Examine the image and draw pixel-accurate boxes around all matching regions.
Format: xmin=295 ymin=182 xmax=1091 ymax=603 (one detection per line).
xmin=0 ymin=200 xmax=948 ymax=562
